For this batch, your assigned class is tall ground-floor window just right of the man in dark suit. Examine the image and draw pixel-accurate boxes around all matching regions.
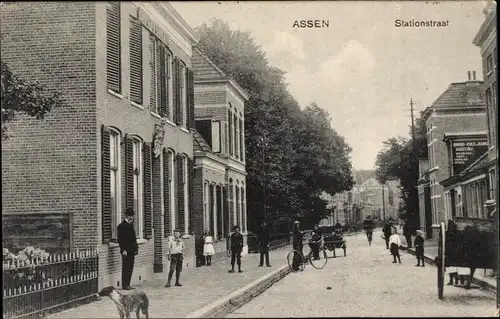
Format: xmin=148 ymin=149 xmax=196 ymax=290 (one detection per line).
xmin=132 ymin=139 xmax=144 ymax=238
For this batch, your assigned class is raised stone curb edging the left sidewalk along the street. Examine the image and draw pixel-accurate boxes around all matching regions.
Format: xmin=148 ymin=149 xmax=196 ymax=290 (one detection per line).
xmin=185 ymin=265 xmax=290 ymax=318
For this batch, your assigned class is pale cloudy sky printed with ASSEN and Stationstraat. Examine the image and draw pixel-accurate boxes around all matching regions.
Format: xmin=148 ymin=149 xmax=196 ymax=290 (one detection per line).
xmin=171 ymin=1 xmax=485 ymax=169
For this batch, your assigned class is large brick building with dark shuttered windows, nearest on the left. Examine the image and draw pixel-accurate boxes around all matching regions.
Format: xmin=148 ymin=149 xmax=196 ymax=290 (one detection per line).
xmin=1 ymin=2 xmax=201 ymax=287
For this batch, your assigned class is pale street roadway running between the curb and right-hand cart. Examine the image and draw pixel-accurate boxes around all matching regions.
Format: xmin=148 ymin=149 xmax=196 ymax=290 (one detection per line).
xmin=228 ymin=232 xmax=496 ymax=318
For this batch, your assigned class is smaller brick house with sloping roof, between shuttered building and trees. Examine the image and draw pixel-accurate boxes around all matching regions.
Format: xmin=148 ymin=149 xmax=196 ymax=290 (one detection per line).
xmin=193 ymin=49 xmax=248 ymax=259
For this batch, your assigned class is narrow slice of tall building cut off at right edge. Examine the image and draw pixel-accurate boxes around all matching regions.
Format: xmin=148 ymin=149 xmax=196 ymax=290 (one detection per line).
xmin=473 ymin=1 xmax=499 ymax=221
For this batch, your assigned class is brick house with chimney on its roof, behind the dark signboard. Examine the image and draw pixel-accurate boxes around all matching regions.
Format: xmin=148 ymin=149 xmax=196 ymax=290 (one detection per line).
xmin=423 ymin=71 xmax=486 ymax=238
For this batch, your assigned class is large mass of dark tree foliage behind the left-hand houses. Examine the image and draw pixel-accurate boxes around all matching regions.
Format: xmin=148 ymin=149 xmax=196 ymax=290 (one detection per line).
xmin=197 ymin=19 xmax=353 ymax=230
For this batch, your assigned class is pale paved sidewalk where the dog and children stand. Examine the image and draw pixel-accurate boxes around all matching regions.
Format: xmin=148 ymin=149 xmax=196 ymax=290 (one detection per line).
xmin=48 ymin=246 xmax=291 ymax=318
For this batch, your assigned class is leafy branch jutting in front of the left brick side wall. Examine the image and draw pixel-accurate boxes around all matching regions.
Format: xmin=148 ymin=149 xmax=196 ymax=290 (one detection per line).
xmin=1 ymin=61 xmax=63 ymax=139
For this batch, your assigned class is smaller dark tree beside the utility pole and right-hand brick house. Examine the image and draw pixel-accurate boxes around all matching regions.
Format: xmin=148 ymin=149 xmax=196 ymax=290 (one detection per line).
xmin=376 ymin=114 xmax=427 ymax=229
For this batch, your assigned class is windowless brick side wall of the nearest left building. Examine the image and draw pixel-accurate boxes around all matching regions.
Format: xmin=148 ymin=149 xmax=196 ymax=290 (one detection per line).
xmin=0 ymin=2 xmax=100 ymax=249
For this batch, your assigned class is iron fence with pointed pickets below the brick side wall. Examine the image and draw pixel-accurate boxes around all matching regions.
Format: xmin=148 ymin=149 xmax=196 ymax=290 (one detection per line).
xmin=3 ymin=250 xmax=99 ymax=319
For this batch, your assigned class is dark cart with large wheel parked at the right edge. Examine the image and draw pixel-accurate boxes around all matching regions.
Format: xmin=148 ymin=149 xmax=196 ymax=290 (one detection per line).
xmin=435 ymin=217 xmax=498 ymax=299
